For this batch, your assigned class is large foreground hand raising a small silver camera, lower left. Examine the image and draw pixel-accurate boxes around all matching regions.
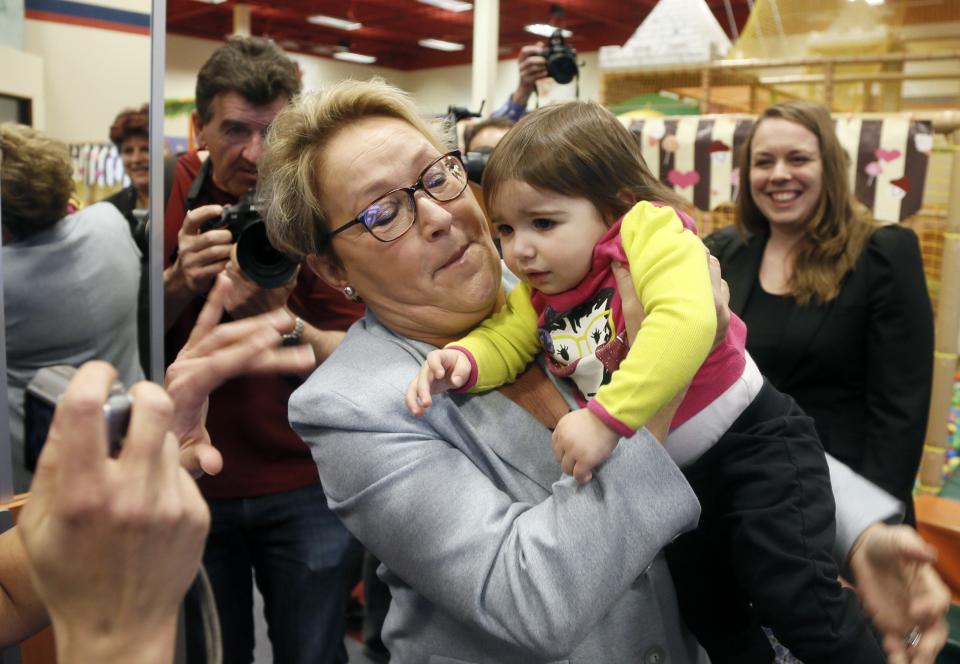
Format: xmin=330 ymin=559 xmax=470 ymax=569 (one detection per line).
xmin=19 ymin=362 xmax=210 ymax=664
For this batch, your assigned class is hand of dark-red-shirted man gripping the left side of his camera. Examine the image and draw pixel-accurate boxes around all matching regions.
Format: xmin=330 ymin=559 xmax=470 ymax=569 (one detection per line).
xmin=174 ymin=205 xmax=233 ymax=295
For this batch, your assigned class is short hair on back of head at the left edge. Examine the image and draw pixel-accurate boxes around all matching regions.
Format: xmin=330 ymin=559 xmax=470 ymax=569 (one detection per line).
xmin=0 ymin=122 xmax=73 ymax=239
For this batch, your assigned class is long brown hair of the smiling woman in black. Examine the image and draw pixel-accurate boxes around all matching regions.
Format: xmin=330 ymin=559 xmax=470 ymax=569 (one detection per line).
xmin=736 ymin=101 xmax=876 ymax=304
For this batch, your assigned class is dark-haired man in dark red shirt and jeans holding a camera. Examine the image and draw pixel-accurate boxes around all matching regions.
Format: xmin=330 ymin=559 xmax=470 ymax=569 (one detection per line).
xmin=164 ymin=37 xmax=362 ymax=664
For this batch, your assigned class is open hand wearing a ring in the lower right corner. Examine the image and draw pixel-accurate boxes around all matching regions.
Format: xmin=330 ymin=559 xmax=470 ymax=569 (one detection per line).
xmin=850 ymin=524 xmax=950 ymax=664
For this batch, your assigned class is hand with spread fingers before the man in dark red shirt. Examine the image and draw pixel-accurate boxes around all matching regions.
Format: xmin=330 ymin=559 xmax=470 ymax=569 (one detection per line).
xmin=165 ymin=275 xmax=315 ymax=477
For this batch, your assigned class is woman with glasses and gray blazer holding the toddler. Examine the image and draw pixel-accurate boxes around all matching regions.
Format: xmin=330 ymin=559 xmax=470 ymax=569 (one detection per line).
xmin=246 ymin=81 xmax=945 ymax=664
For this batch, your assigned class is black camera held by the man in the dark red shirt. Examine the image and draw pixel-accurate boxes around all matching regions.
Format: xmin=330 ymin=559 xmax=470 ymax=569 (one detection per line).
xmin=200 ymin=191 xmax=298 ymax=288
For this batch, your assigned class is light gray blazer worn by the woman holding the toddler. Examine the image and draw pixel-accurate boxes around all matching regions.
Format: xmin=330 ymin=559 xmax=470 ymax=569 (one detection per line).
xmin=290 ymin=311 xmax=889 ymax=664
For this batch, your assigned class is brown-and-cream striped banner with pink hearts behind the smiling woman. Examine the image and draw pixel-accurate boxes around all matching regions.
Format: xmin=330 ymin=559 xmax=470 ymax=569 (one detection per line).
xmin=630 ymin=116 xmax=933 ymax=222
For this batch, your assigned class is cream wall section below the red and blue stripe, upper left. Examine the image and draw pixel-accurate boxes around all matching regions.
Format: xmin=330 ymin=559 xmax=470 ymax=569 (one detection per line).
xmin=23 ymin=16 xmax=150 ymax=143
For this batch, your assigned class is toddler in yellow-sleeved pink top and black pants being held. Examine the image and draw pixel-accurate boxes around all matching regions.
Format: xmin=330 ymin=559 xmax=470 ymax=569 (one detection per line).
xmin=407 ymin=102 xmax=885 ymax=664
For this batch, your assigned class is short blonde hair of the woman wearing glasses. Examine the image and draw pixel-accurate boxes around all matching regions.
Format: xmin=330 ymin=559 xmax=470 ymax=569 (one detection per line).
xmin=258 ymin=78 xmax=448 ymax=259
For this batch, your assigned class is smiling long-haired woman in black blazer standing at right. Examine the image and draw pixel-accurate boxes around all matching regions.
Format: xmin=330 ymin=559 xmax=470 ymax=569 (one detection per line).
xmin=706 ymin=101 xmax=933 ymax=524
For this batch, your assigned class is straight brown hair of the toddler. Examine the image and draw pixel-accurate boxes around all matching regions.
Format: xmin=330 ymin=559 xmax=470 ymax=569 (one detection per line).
xmin=483 ymin=101 xmax=687 ymax=221
